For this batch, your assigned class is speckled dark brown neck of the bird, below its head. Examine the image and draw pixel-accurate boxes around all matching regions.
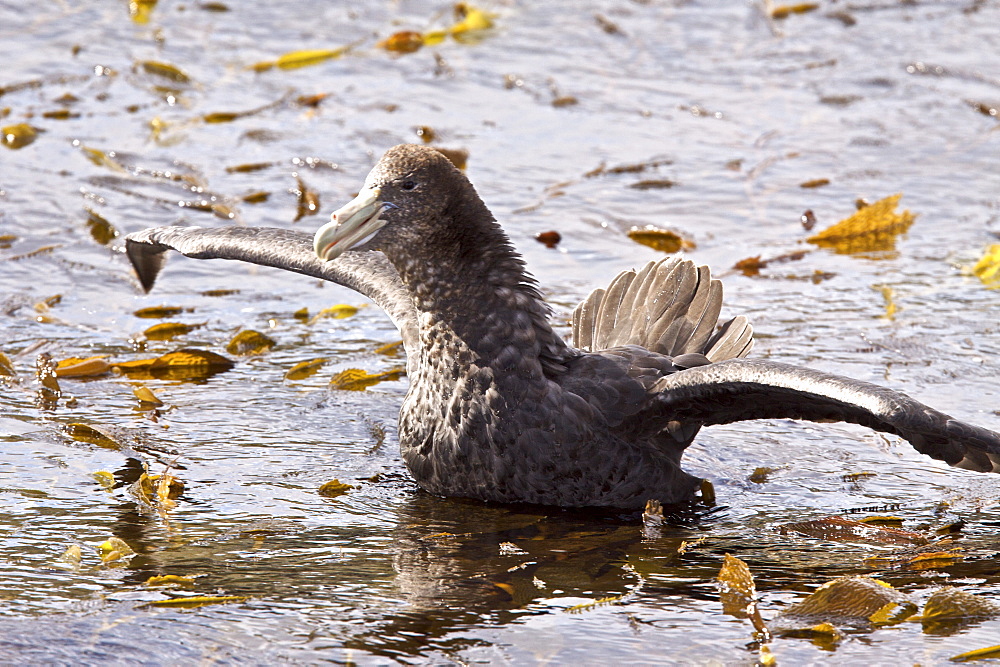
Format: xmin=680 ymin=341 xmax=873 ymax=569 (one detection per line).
xmin=390 ymin=196 xmax=572 ymax=380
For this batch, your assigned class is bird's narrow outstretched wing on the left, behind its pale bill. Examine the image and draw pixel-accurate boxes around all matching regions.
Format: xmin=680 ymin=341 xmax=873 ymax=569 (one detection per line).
xmin=125 ymin=227 xmax=418 ymax=358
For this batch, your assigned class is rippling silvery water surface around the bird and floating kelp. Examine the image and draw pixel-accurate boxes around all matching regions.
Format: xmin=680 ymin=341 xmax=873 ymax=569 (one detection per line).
xmin=0 ymin=0 xmax=1000 ymax=664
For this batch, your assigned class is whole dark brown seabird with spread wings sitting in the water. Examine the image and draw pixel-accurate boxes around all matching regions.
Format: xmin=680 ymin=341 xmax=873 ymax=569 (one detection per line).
xmin=126 ymin=145 xmax=1000 ymax=509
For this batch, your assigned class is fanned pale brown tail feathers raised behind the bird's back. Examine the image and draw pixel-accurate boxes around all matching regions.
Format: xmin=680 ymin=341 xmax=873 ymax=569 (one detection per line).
xmin=573 ymin=257 xmax=753 ymax=361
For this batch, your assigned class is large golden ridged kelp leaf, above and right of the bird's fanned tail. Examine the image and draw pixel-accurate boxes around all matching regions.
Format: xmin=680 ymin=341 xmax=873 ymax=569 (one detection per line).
xmin=806 ymin=194 xmax=916 ymax=254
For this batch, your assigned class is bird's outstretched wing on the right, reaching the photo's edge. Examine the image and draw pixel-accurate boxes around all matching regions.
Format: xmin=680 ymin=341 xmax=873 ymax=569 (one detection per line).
xmin=645 ymin=359 xmax=1000 ymax=472
